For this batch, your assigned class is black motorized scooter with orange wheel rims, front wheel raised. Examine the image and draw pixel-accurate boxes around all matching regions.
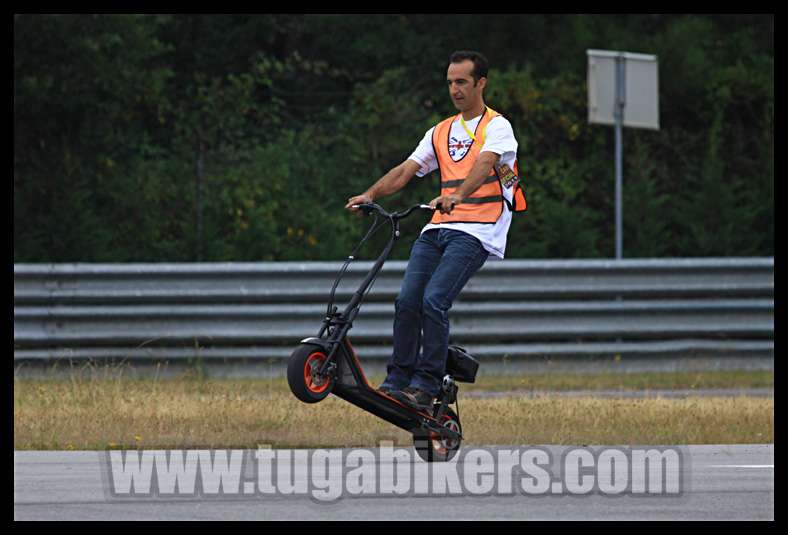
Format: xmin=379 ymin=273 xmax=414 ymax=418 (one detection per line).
xmin=287 ymin=203 xmax=479 ymax=462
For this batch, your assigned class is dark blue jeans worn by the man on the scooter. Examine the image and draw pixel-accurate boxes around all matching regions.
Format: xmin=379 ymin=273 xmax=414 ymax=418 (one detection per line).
xmin=383 ymin=228 xmax=489 ymax=396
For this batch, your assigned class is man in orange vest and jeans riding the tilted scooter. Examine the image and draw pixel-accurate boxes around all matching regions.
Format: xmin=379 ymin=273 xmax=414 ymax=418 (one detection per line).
xmin=345 ymin=51 xmax=525 ymax=410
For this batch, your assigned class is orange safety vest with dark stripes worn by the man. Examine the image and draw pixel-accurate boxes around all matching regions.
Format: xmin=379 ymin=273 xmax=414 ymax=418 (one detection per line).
xmin=430 ymin=108 xmax=526 ymax=224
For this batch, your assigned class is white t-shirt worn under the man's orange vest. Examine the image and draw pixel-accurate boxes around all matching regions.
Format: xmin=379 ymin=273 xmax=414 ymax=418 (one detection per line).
xmin=408 ymin=115 xmax=517 ymax=259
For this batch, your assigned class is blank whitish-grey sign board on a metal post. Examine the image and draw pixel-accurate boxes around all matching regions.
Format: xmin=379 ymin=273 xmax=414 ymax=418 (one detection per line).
xmin=587 ymin=50 xmax=659 ymax=130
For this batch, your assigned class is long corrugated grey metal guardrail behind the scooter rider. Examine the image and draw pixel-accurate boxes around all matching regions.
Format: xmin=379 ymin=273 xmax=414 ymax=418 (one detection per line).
xmin=14 ymin=258 xmax=774 ymax=361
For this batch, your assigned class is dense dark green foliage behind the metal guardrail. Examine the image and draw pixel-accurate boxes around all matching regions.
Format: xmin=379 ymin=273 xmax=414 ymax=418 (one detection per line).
xmin=13 ymin=15 xmax=774 ymax=262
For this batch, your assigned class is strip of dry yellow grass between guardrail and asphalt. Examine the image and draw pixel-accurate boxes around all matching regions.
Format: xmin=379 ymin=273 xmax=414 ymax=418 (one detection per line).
xmin=14 ymin=374 xmax=774 ymax=449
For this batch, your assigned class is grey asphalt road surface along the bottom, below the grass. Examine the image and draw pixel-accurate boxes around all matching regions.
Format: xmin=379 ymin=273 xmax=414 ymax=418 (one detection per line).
xmin=14 ymin=444 xmax=774 ymax=520
